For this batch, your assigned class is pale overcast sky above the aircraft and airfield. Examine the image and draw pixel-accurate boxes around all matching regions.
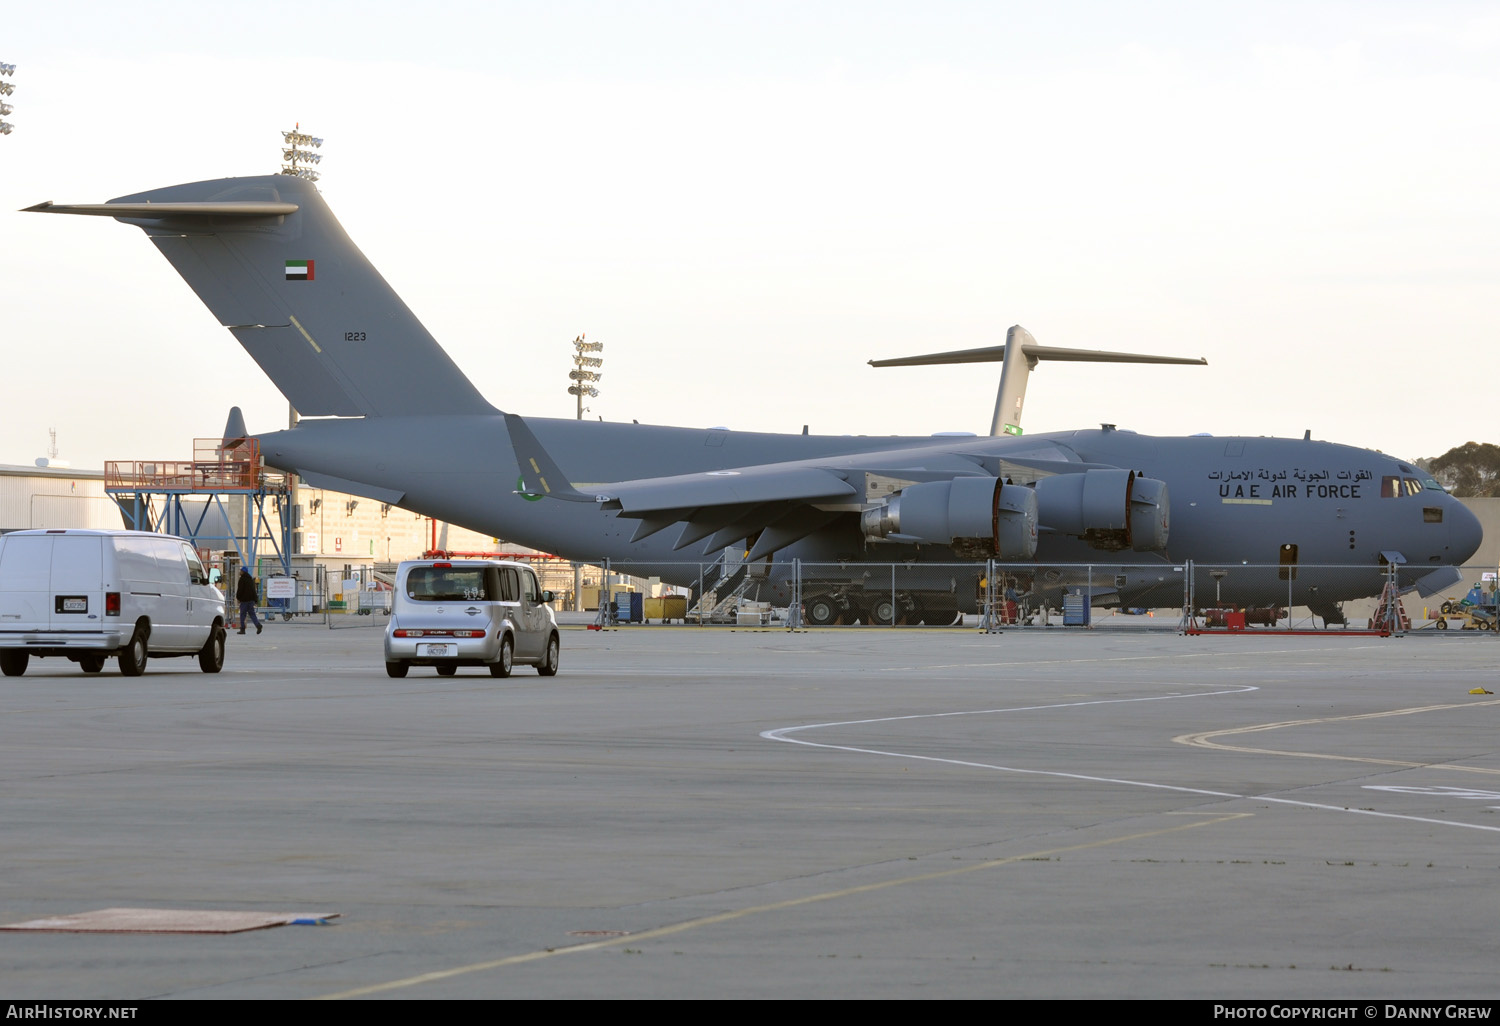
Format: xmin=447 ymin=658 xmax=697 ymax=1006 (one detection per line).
xmin=0 ymin=0 xmax=1500 ymax=467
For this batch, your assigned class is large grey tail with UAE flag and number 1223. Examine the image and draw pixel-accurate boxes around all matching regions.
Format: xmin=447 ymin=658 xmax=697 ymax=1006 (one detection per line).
xmin=27 ymin=176 xmax=495 ymax=417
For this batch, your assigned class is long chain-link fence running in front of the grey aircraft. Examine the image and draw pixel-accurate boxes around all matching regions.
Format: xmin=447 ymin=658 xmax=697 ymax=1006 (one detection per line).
xmin=599 ymin=552 xmax=1500 ymax=633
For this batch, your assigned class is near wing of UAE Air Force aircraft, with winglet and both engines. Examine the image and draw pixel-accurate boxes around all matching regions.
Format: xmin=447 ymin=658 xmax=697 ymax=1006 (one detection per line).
xmin=506 ymin=414 xmax=1170 ymax=560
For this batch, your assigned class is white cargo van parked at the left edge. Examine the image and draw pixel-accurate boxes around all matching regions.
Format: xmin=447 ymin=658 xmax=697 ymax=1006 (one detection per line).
xmin=0 ymin=531 xmax=225 ymax=677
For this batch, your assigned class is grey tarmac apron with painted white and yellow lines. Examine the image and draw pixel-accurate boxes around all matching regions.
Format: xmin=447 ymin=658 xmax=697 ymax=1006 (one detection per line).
xmin=0 ymin=612 xmax=1500 ymax=1001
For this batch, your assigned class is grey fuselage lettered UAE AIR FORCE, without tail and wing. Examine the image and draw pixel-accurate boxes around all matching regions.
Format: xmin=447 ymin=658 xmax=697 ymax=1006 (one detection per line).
xmin=260 ymin=414 xmax=1481 ymax=605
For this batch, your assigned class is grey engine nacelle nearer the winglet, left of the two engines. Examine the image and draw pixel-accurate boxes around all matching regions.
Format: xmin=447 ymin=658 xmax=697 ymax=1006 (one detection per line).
xmin=861 ymin=477 xmax=1037 ymax=560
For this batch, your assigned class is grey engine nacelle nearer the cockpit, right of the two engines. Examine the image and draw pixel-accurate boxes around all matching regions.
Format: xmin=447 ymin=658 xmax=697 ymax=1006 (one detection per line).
xmin=1037 ymin=470 xmax=1170 ymax=552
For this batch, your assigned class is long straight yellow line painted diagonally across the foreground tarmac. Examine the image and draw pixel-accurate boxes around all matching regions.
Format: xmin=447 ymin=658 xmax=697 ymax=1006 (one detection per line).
xmin=318 ymin=813 xmax=1254 ymax=1001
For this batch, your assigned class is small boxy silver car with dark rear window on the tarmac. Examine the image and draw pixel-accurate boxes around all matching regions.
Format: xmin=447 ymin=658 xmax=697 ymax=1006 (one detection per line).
xmin=386 ymin=560 xmax=560 ymax=677
